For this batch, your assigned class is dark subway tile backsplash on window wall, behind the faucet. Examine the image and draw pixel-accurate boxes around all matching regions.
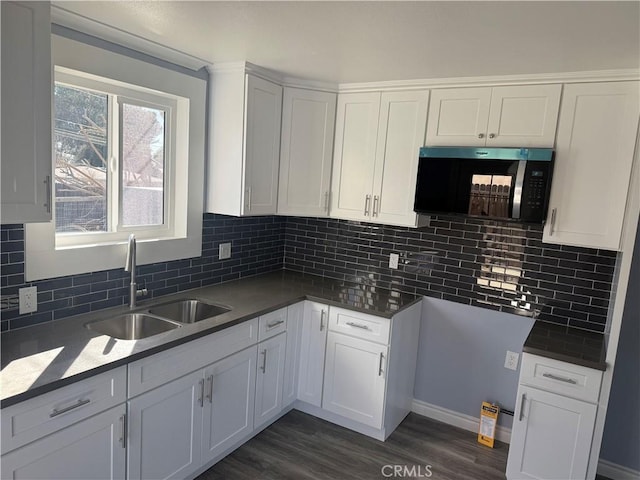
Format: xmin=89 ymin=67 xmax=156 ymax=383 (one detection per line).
xmin=0 ymin=214 xmax=286 ymax=331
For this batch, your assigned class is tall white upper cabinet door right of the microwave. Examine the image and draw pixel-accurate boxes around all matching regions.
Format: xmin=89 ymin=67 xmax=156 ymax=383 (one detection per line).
xmin=543 ymin=82 xmax=640 ymax=250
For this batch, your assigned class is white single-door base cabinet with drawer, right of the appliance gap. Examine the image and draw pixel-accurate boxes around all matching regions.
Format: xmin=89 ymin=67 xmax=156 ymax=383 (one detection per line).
xmin=507 ymin=353 xmax=602 ymax=480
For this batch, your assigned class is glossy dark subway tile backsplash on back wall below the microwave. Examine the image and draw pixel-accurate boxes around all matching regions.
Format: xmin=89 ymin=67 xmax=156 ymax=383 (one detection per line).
xmin=284 ymin=216 xmax=616 ymax=332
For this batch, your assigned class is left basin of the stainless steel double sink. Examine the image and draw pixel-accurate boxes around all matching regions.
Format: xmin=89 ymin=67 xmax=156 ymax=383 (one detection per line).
xmin=85 ymin=313 xmax=180 ymax=340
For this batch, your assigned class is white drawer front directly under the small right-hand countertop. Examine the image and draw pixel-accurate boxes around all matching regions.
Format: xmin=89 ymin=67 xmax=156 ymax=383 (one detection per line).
xmin=520 ymin=353 xmax=602 ymax=403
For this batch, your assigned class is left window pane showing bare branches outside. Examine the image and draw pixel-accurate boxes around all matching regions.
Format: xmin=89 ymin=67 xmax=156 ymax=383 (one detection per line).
xmin=54 ymin=83 xmax=108 ymax=233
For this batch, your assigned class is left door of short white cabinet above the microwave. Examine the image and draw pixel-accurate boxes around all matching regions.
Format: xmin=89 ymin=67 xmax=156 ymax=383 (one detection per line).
xmin=426 ymin=87 xmax=491 ymax=147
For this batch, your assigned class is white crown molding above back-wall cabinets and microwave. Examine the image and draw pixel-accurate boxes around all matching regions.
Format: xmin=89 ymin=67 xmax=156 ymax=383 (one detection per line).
xmin=338 ymin=69 xmax=640 ymax=93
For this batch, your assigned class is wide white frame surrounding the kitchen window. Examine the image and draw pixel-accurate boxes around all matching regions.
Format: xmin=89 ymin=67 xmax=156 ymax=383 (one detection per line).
xmin=25 ymin=35 xmax=206 ymax=281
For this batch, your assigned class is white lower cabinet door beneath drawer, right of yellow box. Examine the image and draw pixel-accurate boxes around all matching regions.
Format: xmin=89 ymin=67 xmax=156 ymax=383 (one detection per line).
xmin=507 ymin=385 xmax=596 ymax=480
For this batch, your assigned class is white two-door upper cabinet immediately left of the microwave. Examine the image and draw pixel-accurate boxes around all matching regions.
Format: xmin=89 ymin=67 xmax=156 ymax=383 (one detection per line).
xmin=331 ymin=90 xmax=429 ymax=226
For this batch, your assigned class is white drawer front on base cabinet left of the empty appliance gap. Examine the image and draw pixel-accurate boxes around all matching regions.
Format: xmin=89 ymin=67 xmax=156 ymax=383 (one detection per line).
xmin=329 ymin=307 xmax=391 ymax=345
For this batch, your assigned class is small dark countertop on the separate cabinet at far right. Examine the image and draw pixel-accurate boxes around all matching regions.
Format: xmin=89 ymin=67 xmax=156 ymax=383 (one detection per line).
xmin=522 ymin=320 xmax=607 ymax=371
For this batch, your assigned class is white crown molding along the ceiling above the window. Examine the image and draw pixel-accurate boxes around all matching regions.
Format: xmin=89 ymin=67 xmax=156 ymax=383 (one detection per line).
xmin=51 ymin=5 xmax=209 ymax=70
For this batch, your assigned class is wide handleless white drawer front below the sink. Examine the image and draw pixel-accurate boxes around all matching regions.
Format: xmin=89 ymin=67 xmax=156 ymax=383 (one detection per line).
xmin=128 ymin=318 xmax=258 ymax=398
